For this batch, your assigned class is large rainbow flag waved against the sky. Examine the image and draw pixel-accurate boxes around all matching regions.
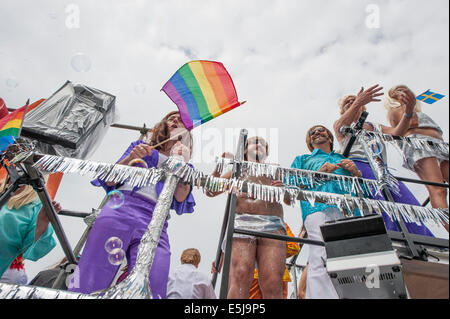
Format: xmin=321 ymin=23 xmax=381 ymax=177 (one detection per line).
xmin=161 ymin=60 xmax=244 ymax=130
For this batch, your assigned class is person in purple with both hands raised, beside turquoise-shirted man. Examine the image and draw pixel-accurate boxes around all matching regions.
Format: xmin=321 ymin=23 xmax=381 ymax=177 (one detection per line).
xmin=333 ymin=85 xmax=434 ymax=237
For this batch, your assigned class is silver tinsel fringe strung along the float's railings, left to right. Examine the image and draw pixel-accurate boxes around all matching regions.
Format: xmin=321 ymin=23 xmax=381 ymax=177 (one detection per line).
xmin=22 ymin=155 xmax=448 ymax=228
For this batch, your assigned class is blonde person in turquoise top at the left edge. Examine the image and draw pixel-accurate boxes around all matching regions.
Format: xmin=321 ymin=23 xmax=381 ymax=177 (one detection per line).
xmin=0 ymin=178 xmax=61 ymax=277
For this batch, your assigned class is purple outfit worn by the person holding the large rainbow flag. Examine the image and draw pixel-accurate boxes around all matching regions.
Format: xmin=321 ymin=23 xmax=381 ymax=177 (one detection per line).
xmin=68 ymin=141 xmax=195 ymax=299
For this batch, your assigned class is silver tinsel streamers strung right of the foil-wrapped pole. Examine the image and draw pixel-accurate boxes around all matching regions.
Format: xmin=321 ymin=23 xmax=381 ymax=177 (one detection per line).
xmin=140 ymin=157 xmax=448 ymax=228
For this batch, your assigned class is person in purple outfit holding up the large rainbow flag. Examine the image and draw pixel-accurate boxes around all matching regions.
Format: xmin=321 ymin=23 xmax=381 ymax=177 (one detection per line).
xmin=68 ymin=112 xmax=195 ymax=299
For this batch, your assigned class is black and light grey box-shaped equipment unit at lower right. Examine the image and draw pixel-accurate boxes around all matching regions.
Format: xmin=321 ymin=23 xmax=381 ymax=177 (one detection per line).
xmin=320 ymin=215 xmax=408 ymax=299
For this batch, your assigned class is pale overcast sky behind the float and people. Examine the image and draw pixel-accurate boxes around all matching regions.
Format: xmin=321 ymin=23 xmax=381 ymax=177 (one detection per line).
xmin=0 ymin=0 xmax=449 ymax=298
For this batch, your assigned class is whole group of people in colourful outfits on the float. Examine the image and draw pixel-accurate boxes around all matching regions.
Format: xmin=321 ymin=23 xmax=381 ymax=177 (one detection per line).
xmin=0 ymin=85 xmax=449 ymax=299
